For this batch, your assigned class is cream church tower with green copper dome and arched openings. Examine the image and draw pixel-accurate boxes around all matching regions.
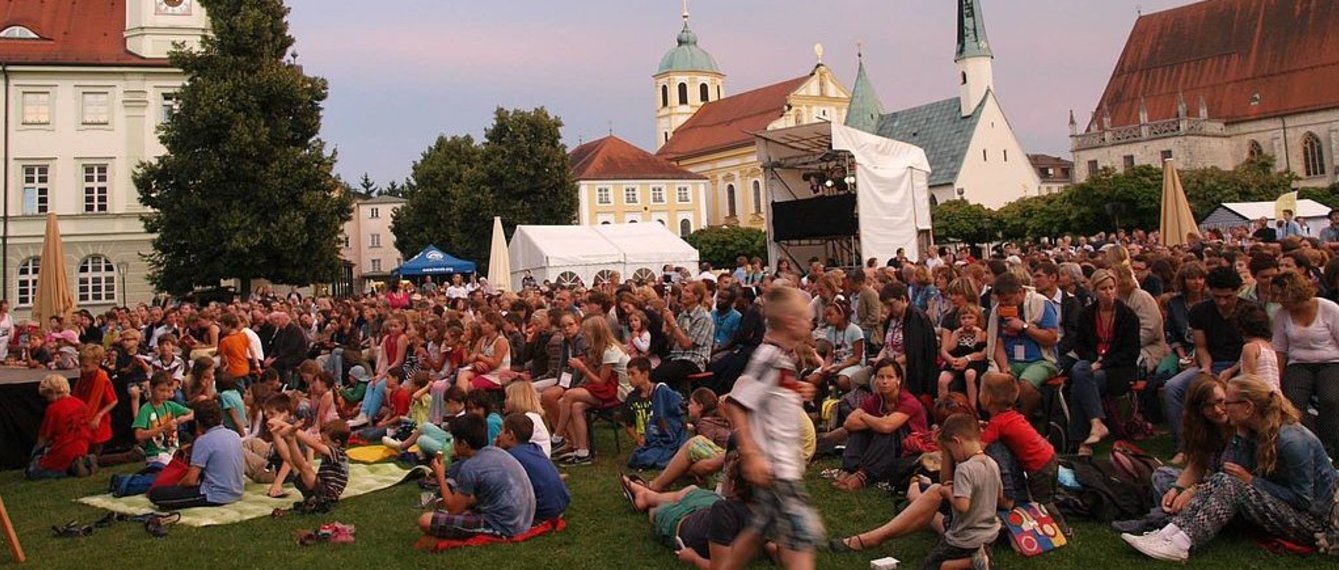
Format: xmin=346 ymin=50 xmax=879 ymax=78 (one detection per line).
xmin=652 ymin=0 xmax=726 ymax=149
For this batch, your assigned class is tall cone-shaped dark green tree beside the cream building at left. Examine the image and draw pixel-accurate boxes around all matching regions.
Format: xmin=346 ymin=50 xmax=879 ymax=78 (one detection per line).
xmin=134 ymin=0 xmax=352 ymax=294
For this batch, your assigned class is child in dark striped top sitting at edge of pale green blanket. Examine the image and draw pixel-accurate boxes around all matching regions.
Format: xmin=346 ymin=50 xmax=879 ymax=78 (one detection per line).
xmin=269 ymin=417 xmax=348 ymax=512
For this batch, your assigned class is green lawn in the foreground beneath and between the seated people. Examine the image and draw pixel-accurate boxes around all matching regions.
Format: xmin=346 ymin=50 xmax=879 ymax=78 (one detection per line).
xmin=0 ymin=425 xmax=1336 ymax=570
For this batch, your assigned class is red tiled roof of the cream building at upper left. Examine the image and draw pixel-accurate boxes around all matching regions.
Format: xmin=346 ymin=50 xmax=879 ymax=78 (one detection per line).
xmin=0 ymin=0 xmax=167 ymax=66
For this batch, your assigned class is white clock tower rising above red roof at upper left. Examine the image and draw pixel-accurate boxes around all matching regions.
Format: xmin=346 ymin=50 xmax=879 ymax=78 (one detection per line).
xmin=126 ymin=0 xmax=209 ymax=59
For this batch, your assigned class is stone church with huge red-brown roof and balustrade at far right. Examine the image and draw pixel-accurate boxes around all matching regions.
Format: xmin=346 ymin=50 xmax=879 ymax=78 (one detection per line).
xmin=1070 ymin=0 xmax=1339 ymax=186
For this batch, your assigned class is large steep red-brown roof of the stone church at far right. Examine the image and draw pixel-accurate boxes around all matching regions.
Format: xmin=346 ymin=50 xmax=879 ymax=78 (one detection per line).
xmin=1089 ymin=0 xmax=1339 ymax=130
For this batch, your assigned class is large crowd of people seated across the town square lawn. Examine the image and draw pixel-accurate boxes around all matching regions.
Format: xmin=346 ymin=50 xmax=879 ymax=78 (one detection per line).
xmin=20 ymin=211 xmax=1339 ymax=569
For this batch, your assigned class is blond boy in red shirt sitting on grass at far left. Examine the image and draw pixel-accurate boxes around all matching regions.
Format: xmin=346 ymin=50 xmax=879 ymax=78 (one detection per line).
xmin=24 ymin=375 xmax=98 ymax=479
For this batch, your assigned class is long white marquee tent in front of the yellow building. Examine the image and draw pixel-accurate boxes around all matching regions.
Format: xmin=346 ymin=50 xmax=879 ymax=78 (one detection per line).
xmin=507 ymin=223 xmax=698 ymax=286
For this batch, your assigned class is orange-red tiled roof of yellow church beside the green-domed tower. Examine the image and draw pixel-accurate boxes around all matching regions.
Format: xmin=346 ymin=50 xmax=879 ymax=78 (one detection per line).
xmin=656 ymin=75 xmax=810 ymax=161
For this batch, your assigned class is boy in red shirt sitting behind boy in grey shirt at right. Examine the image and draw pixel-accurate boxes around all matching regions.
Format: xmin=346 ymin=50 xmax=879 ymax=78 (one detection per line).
xmin=980 ymin=372 xmax=1071 ymax=537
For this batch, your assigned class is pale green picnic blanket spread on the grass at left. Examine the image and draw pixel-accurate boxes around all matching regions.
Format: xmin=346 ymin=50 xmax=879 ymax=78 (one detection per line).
xmin=78 ymin=463 xmax=426 ymax=527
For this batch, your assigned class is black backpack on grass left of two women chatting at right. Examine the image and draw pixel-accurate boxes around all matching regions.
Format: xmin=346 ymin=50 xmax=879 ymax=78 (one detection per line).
xmin=1056 ymin=455 xmax=1153 ymax=522
